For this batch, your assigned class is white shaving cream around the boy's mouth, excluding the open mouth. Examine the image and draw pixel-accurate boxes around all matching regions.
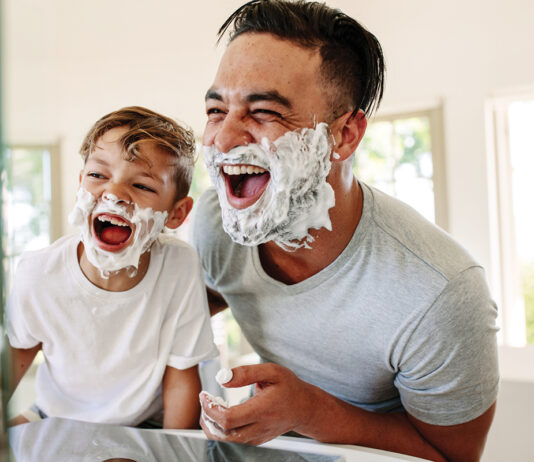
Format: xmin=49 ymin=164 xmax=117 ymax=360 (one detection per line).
xmin=69 ymin=188 xmax=167 ymax=279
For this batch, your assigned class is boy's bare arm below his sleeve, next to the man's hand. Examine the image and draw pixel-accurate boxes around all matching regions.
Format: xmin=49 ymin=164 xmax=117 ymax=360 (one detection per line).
xmin=162 ymin=366 xmax=202 ymax=428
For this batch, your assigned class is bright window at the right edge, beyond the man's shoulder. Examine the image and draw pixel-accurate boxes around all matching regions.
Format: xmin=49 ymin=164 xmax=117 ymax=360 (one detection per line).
xmin=487 ymin=92 xmax=534 ymax=347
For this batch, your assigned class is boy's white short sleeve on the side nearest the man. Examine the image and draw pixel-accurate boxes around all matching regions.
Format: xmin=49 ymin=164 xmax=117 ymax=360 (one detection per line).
xmin=167 ymin=249 xmax=219 ymax=369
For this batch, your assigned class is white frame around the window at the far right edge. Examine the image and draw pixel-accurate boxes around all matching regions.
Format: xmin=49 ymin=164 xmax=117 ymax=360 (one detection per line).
xmin=484 ymin=86 xmax=534 ymax=382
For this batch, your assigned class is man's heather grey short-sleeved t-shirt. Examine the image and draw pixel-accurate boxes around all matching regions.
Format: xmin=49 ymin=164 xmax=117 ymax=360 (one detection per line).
xmin=192 ymin=184 xmax=499 ymax=425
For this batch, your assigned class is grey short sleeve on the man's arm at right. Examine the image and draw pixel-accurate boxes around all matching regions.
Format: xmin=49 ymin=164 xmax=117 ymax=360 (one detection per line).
xmin=395 ymin=267 xmax=499 ymax=425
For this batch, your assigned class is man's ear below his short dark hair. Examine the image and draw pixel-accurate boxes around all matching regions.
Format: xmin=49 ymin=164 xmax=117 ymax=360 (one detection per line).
xmin=330 ymin=109 xmax=367 ymax=162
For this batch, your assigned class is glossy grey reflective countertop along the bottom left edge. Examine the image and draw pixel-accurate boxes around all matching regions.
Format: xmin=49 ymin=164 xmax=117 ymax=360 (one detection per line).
xmin=9 ymin=418 xmax=344 ymax=462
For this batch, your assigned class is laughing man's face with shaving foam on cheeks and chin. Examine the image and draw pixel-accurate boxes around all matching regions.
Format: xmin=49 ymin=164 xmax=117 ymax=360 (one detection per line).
xmin=203 ymin=34 xmax=333 ymax=249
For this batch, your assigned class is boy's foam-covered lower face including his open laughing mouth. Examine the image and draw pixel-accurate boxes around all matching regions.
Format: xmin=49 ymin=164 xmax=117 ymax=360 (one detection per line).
xmin=69 ymin=187 xmax=167 ymax=278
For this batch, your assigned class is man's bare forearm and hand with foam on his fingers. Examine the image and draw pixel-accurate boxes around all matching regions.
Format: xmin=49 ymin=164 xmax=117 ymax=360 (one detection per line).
xmin=201 ymin=364 xmax=495 ymax=461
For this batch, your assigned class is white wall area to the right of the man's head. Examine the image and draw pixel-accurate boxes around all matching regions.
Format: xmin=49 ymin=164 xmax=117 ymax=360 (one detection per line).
xmin=335 ymin=0 xmax=534 ymax=278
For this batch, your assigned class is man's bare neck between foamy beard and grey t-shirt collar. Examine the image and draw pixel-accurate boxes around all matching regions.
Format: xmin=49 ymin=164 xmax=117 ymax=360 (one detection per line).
xmin=258 ymin=180 xmax=363 ymax=285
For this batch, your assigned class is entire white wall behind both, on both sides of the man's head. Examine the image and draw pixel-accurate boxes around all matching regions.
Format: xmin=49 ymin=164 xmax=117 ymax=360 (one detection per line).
xmin=3 ymin=0 xmax=534 ymax=270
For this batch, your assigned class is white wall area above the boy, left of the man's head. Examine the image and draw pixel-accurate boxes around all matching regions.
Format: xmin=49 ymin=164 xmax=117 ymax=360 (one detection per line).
xmin=3 ymin=0 xmax=246 ymax=235
